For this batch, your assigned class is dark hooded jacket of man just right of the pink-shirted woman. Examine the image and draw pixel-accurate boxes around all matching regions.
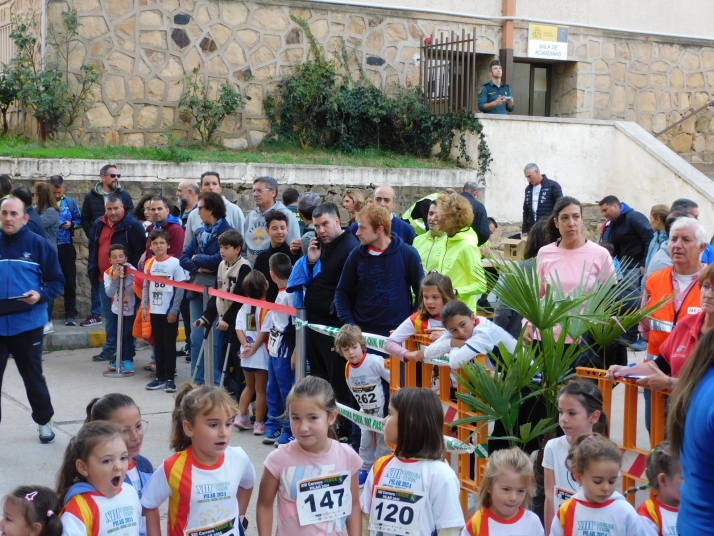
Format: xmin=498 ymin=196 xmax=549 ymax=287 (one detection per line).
xmin=601 ymin=203 xmax=653 ymax=269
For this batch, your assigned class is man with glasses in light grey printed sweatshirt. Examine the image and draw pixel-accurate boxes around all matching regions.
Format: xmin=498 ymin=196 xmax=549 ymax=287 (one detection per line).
xmin=243 ymin=177 xmax=300 ymax=263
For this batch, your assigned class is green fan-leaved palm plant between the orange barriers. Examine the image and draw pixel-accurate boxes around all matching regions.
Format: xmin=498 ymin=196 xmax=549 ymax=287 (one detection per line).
xmin=455 ymin=261 xmax=672 ymax=449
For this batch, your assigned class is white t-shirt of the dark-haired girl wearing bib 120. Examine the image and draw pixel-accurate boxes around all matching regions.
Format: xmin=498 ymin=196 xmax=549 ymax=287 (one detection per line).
xmin=360 ymin=456 xmax=464 ymax=536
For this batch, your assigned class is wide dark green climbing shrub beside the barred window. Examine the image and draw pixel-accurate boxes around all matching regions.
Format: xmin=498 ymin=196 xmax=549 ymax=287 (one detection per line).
xmin=264 ymin=16 xmax=491 ymax=176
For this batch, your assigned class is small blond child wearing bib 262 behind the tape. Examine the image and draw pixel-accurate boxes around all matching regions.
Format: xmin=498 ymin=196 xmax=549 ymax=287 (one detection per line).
xmin=335 ymin=324 xmax=392 ymax=486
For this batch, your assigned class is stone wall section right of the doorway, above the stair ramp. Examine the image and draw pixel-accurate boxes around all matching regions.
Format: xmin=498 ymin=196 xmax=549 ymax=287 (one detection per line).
xmin=514 ymin=26 xmax=714 ymax=163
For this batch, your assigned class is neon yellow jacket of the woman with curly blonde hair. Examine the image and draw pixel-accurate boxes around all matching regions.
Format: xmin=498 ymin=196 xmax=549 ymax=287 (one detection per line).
xmin=429 ymin=227 xmax=486 ymax=311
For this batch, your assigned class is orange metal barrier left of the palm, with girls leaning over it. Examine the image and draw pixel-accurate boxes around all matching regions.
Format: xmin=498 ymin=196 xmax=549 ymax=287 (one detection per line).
xmin=389 ymin=335 xmax=488 ymax=518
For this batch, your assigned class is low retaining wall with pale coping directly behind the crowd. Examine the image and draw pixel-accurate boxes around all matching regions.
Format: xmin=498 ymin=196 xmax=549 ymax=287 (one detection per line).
xmin=0 ymin=157 xmax=483 ymax=318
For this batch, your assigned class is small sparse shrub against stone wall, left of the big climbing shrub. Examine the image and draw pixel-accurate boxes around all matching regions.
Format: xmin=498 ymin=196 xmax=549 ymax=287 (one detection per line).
xmin=179 ymin=68 xmax=250 ymax=144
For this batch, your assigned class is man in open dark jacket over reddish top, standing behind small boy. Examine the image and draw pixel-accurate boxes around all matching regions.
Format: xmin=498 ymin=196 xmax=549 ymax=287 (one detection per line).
xmin=87 ymin=193 xmax=146 ymax=361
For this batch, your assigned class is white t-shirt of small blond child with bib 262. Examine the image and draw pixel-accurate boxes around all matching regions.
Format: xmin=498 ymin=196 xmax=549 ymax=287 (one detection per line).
xmin=345 ymin=353 xmax=389 ymax=417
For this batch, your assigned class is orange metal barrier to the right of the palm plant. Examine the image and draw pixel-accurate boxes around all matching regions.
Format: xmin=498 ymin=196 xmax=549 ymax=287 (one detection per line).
xmin=576 ymin=367 xmax=670 ymax=506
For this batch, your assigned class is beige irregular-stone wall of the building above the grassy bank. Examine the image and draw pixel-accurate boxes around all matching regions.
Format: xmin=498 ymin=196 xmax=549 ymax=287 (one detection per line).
xmin=0 ymin=0 xmax=714 ymax=162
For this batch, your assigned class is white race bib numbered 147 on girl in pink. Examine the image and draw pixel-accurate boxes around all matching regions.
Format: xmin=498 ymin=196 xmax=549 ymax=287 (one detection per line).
xmin=297 ymin=473 xmax=352 ymax=527
